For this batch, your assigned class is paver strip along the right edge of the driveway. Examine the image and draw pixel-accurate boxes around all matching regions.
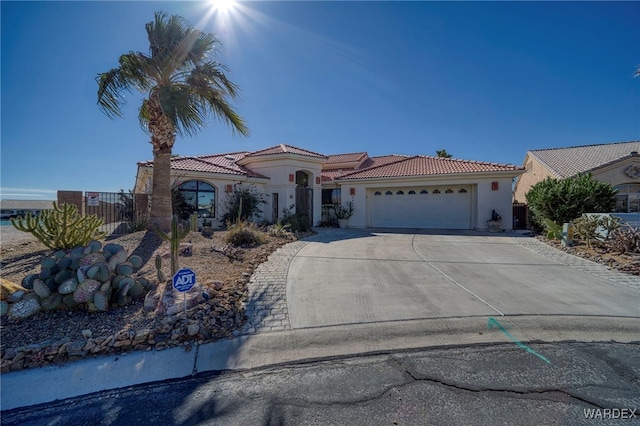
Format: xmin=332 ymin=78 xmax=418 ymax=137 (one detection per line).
xmin=513 ymin=238 xmax=640 ymax=289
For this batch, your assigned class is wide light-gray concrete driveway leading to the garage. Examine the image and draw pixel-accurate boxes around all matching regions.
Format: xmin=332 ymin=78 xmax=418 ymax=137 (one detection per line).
xmin=287 ymin=230 xmax=640 ymax=329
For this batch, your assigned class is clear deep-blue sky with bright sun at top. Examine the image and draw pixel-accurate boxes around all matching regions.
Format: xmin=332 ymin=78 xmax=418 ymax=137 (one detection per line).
xmin=0 ymin=1 xmax=640 ymax=199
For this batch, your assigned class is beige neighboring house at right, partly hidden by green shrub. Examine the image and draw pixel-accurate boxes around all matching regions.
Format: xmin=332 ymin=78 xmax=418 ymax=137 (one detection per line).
xmin=513 ymin=141 xmax=640 ymax=213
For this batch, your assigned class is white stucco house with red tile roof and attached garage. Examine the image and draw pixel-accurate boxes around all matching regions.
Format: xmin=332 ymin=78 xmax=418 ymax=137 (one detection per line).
xmin=135 ymin=145 xmax=524 ymax=229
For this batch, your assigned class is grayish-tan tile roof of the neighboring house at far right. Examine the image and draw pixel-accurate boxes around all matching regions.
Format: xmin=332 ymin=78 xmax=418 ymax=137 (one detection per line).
xmin=529 ymin=141 xmax=640 ymax=179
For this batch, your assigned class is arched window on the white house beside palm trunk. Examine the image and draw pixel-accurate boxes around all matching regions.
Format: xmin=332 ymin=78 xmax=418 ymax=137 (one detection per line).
xmin=173 ymin=180 xmax=216 ymax=219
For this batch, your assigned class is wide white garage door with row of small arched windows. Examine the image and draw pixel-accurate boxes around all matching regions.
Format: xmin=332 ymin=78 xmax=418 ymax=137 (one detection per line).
xmin=369 ymin=185 xmax=471 ymax=229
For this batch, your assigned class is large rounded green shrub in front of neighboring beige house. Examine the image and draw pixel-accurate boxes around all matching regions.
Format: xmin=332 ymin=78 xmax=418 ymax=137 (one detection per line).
xmin=526 ymin=174 xmax=616 ymax=229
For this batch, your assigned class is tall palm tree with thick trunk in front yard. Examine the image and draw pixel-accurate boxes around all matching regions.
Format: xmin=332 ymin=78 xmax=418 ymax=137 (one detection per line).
xmin=96 ymin=12 xmax=249 ymax=230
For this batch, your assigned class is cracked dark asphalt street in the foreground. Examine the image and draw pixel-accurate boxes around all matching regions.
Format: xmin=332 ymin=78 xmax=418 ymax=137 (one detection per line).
xmin=2 ymin=343 xmax=640 ymax=426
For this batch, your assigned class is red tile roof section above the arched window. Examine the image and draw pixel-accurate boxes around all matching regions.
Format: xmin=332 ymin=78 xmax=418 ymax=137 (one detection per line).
xmin=138 ymin=152 xmax=269 ymax=179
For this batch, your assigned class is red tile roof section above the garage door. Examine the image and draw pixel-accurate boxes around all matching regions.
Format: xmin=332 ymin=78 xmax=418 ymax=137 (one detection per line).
xmin=338 ymin=155 xmax=524 ymax=179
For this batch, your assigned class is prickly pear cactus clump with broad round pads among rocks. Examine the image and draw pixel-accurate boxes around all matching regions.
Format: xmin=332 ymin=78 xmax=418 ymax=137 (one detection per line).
xmin=0 ymin=241 xmax=154 ymax=319
